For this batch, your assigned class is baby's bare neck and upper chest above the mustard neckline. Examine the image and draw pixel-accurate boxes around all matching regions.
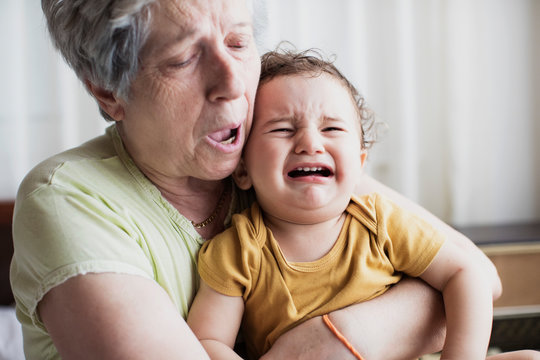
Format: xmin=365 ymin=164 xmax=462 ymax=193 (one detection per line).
xmin=264 ymin=213 xmax=345 ymax=262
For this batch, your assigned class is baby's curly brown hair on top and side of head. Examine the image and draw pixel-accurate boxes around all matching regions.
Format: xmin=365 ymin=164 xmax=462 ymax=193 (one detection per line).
xmin=259 ymin=44 xmax=376 ymax=149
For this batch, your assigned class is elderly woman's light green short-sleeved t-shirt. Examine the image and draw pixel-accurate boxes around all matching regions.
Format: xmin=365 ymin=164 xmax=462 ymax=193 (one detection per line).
xmin=10 ymin=125 xmax=236 ymax=359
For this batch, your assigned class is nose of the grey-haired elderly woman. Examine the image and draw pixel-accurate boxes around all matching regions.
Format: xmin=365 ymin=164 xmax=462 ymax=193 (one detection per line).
xmin=206 ymin=48 xmax=245 ymax=101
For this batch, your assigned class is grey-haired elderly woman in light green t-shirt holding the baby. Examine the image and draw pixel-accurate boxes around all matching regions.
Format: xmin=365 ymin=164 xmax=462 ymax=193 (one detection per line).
xmin=11 ymin=0 xmax=499 ymax=359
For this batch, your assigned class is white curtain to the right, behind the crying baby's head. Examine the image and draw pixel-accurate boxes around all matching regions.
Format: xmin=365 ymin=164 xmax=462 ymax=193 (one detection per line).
xmin=258 ymin=0 xmax=540 ymax=225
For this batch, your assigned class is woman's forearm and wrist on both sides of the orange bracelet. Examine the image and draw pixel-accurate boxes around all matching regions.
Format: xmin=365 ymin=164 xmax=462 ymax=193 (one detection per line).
xmin=263 ymin=278 xmax=446 ymax=360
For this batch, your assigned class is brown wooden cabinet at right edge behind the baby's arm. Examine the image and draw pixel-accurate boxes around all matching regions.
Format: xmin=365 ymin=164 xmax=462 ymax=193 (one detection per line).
xmin=459 ymin=223 xmax=540 ymax=351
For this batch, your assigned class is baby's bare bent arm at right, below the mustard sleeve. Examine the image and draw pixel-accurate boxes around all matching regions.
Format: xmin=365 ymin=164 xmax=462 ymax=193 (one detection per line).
xmin=421 ymin=241 xmax=493 ymax=359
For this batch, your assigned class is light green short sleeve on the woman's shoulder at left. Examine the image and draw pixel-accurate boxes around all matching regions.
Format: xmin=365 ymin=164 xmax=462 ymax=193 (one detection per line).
xmin=10 ymin=185 xmax=153 ymax=329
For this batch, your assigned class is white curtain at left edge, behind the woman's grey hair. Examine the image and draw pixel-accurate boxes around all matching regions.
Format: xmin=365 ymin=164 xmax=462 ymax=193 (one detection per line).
xmin=0 ymin=0 xmax=107 ymax=200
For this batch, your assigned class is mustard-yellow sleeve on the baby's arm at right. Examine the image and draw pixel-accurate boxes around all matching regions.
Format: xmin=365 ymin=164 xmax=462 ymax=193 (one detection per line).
xmin=373 ymin=195 xmax=446 ymax=277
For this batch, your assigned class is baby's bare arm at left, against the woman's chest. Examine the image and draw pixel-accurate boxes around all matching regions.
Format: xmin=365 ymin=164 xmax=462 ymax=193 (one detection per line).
xmin=187 ymin=281 xmax=244 ymax=359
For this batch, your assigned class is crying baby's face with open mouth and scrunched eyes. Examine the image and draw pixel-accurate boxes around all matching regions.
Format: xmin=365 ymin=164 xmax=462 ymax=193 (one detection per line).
xmin=240 ymin=73 xmax=366 ymax=224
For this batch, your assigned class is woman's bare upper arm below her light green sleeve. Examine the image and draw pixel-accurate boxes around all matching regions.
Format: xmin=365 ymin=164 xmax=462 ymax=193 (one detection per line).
xmin=38 ymin=273 xmax=208 ymax=360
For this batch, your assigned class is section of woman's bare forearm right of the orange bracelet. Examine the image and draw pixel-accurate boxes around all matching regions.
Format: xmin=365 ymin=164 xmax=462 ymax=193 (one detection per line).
xmin=330 ymin=278 xmax=446 ymax=360
